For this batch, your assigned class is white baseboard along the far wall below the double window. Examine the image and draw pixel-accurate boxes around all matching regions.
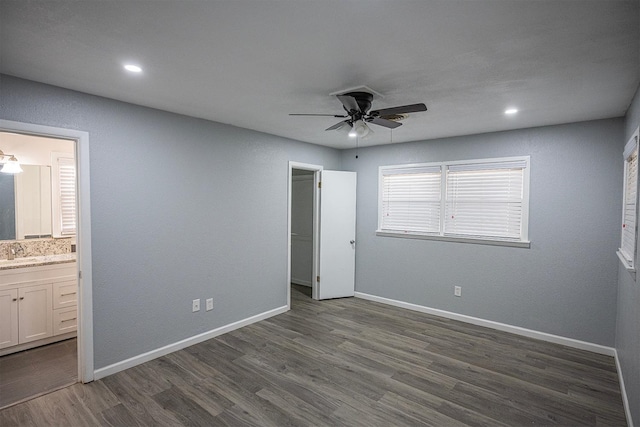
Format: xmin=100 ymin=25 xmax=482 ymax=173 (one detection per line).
xmin=355 ymin=292 xmax=616 ymax=357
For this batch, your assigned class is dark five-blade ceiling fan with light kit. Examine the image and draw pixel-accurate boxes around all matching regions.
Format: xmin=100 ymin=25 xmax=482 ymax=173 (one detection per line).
xmin=289 ymin=92 xmax=427 ymax=138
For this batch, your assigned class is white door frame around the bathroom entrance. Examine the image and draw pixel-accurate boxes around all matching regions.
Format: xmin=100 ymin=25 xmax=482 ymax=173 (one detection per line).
xmin=0 ymin=119 xmax=94 ymax=383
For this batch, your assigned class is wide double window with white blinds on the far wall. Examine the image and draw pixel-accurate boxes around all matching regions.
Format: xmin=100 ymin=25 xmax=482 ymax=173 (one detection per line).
xmin=377 ymin=157 xmax=529 ymax=247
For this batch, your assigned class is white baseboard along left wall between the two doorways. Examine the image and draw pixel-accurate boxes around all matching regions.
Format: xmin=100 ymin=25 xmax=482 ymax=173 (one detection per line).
xmin=93 ymin=306 xmax=289 ymax=380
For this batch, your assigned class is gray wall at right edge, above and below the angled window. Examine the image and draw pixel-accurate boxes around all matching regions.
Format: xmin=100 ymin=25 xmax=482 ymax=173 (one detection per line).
xmin=616 ymin=82 xmax=640 ymax=425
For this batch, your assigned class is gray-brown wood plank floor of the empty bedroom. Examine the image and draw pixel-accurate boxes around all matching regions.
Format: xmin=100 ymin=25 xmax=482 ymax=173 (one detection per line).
xmin=0 ymin=286 xmax=626 ymax=427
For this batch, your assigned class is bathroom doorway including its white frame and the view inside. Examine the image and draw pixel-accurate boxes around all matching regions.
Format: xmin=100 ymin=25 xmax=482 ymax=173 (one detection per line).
xmin=0 ymin=120 xmax=93 ymax=407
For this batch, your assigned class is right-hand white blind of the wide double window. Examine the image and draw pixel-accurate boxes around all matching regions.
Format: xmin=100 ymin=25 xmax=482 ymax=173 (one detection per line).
xmin=444 ymin=160 xmax=527 ymax=241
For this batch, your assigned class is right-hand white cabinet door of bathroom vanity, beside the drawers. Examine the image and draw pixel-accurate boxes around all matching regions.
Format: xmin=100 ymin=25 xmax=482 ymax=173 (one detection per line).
xmin=18 ymin=284 xmax=53 ymax=344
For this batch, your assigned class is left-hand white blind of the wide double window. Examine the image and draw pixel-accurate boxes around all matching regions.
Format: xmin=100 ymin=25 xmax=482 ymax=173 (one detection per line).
xmin=380 ymin=166 xmax=442 ymax=233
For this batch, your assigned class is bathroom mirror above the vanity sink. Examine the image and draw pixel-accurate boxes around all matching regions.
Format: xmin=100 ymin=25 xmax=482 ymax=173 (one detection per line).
xmin=0 ymin=165 xmax=52 ymax=240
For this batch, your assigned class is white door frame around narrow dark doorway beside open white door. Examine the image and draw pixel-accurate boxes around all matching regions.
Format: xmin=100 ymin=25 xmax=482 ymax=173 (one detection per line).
xmin=287 ymin=161 xmax=323 ymax=310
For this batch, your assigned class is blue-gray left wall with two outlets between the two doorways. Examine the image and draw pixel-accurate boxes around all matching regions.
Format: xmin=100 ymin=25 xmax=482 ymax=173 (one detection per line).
xmin=0 ymin=76 xmax=340 ymax=369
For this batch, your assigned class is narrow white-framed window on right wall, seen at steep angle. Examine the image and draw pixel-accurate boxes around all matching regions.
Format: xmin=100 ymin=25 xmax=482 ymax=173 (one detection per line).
xmin=618 ymin=129 xmax=638 ymax=270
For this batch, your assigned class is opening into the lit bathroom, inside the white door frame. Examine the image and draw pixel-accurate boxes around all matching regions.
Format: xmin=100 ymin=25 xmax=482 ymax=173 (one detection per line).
xmin=0 ymin=132 xmax=78 ymax=408
